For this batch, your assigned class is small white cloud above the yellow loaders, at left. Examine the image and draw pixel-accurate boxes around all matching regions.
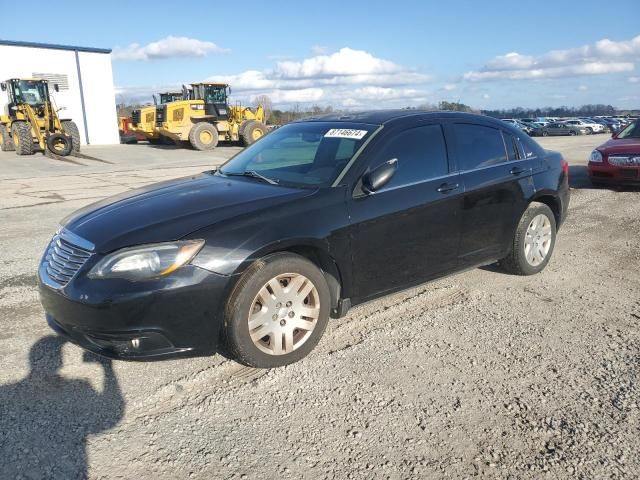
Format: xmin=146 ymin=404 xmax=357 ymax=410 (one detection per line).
xmin=112 ymin=35 xmax=228 ymax=60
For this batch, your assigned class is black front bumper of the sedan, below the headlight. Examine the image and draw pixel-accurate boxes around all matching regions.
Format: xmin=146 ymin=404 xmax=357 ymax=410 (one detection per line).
xmin=38 ymin=262 xmax=233 ymax=359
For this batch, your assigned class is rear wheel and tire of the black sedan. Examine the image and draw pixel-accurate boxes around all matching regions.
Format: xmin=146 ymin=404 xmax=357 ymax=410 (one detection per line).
xmin=499 ymin=202 xmax=556 ymax=275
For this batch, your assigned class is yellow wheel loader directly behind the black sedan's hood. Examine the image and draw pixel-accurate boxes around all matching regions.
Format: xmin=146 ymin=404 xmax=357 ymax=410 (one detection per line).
xmin=156 ymin=83 xmax=267 ymax=150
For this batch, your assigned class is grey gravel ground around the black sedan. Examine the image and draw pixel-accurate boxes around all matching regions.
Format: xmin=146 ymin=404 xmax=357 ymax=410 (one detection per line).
xmin=0 ymin=136 xmax=640 ymax=479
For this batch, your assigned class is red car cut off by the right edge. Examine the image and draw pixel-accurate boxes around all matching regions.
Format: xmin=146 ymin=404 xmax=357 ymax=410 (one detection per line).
xmin=588 ymin=120 xmax=640 ymax=185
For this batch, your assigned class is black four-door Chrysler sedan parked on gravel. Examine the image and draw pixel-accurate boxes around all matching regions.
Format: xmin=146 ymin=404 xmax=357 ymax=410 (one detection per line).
xmin=38 ymin=110 xmax=569 ymax=367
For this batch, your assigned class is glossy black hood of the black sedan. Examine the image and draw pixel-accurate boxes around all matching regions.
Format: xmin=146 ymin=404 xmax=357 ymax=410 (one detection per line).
xmin=61 ymin=173 xmax=314 ymax=253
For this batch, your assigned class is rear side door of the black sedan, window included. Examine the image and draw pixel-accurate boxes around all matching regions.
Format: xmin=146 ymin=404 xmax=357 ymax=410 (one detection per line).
xmin=449 ymin=123 xmax=533 ymax=266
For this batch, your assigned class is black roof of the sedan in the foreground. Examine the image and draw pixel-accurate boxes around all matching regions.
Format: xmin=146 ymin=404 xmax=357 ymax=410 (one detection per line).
xmin=297 ymin=110 xmax=504 ymax=125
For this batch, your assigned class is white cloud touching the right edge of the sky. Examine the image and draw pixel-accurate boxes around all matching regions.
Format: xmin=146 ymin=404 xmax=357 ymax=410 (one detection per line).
xmin=464 ymin=35 xmax=640 ymax=82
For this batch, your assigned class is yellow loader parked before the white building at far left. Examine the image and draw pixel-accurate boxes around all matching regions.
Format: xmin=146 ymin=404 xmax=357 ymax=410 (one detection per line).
xmin=0 ymin=78 xmax=80 ymax=156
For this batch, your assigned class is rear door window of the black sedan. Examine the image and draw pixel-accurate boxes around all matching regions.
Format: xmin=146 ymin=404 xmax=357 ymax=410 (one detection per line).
xmin=453 ymin=123 xmax=507 ymax=170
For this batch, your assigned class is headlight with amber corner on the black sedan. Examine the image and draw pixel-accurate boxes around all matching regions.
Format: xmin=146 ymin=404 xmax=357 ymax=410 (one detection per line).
xmin=89 ymin=240 xmax=204 ymax=280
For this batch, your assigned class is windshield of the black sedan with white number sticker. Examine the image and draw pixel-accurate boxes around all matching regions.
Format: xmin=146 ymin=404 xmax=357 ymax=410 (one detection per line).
xmin=219 ymin=122 xmax=378 ymax=187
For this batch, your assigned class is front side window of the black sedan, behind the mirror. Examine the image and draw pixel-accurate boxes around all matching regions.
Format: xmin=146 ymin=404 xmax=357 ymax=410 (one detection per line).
xmin=372 ymin=125 xmax=449 ymax=191
